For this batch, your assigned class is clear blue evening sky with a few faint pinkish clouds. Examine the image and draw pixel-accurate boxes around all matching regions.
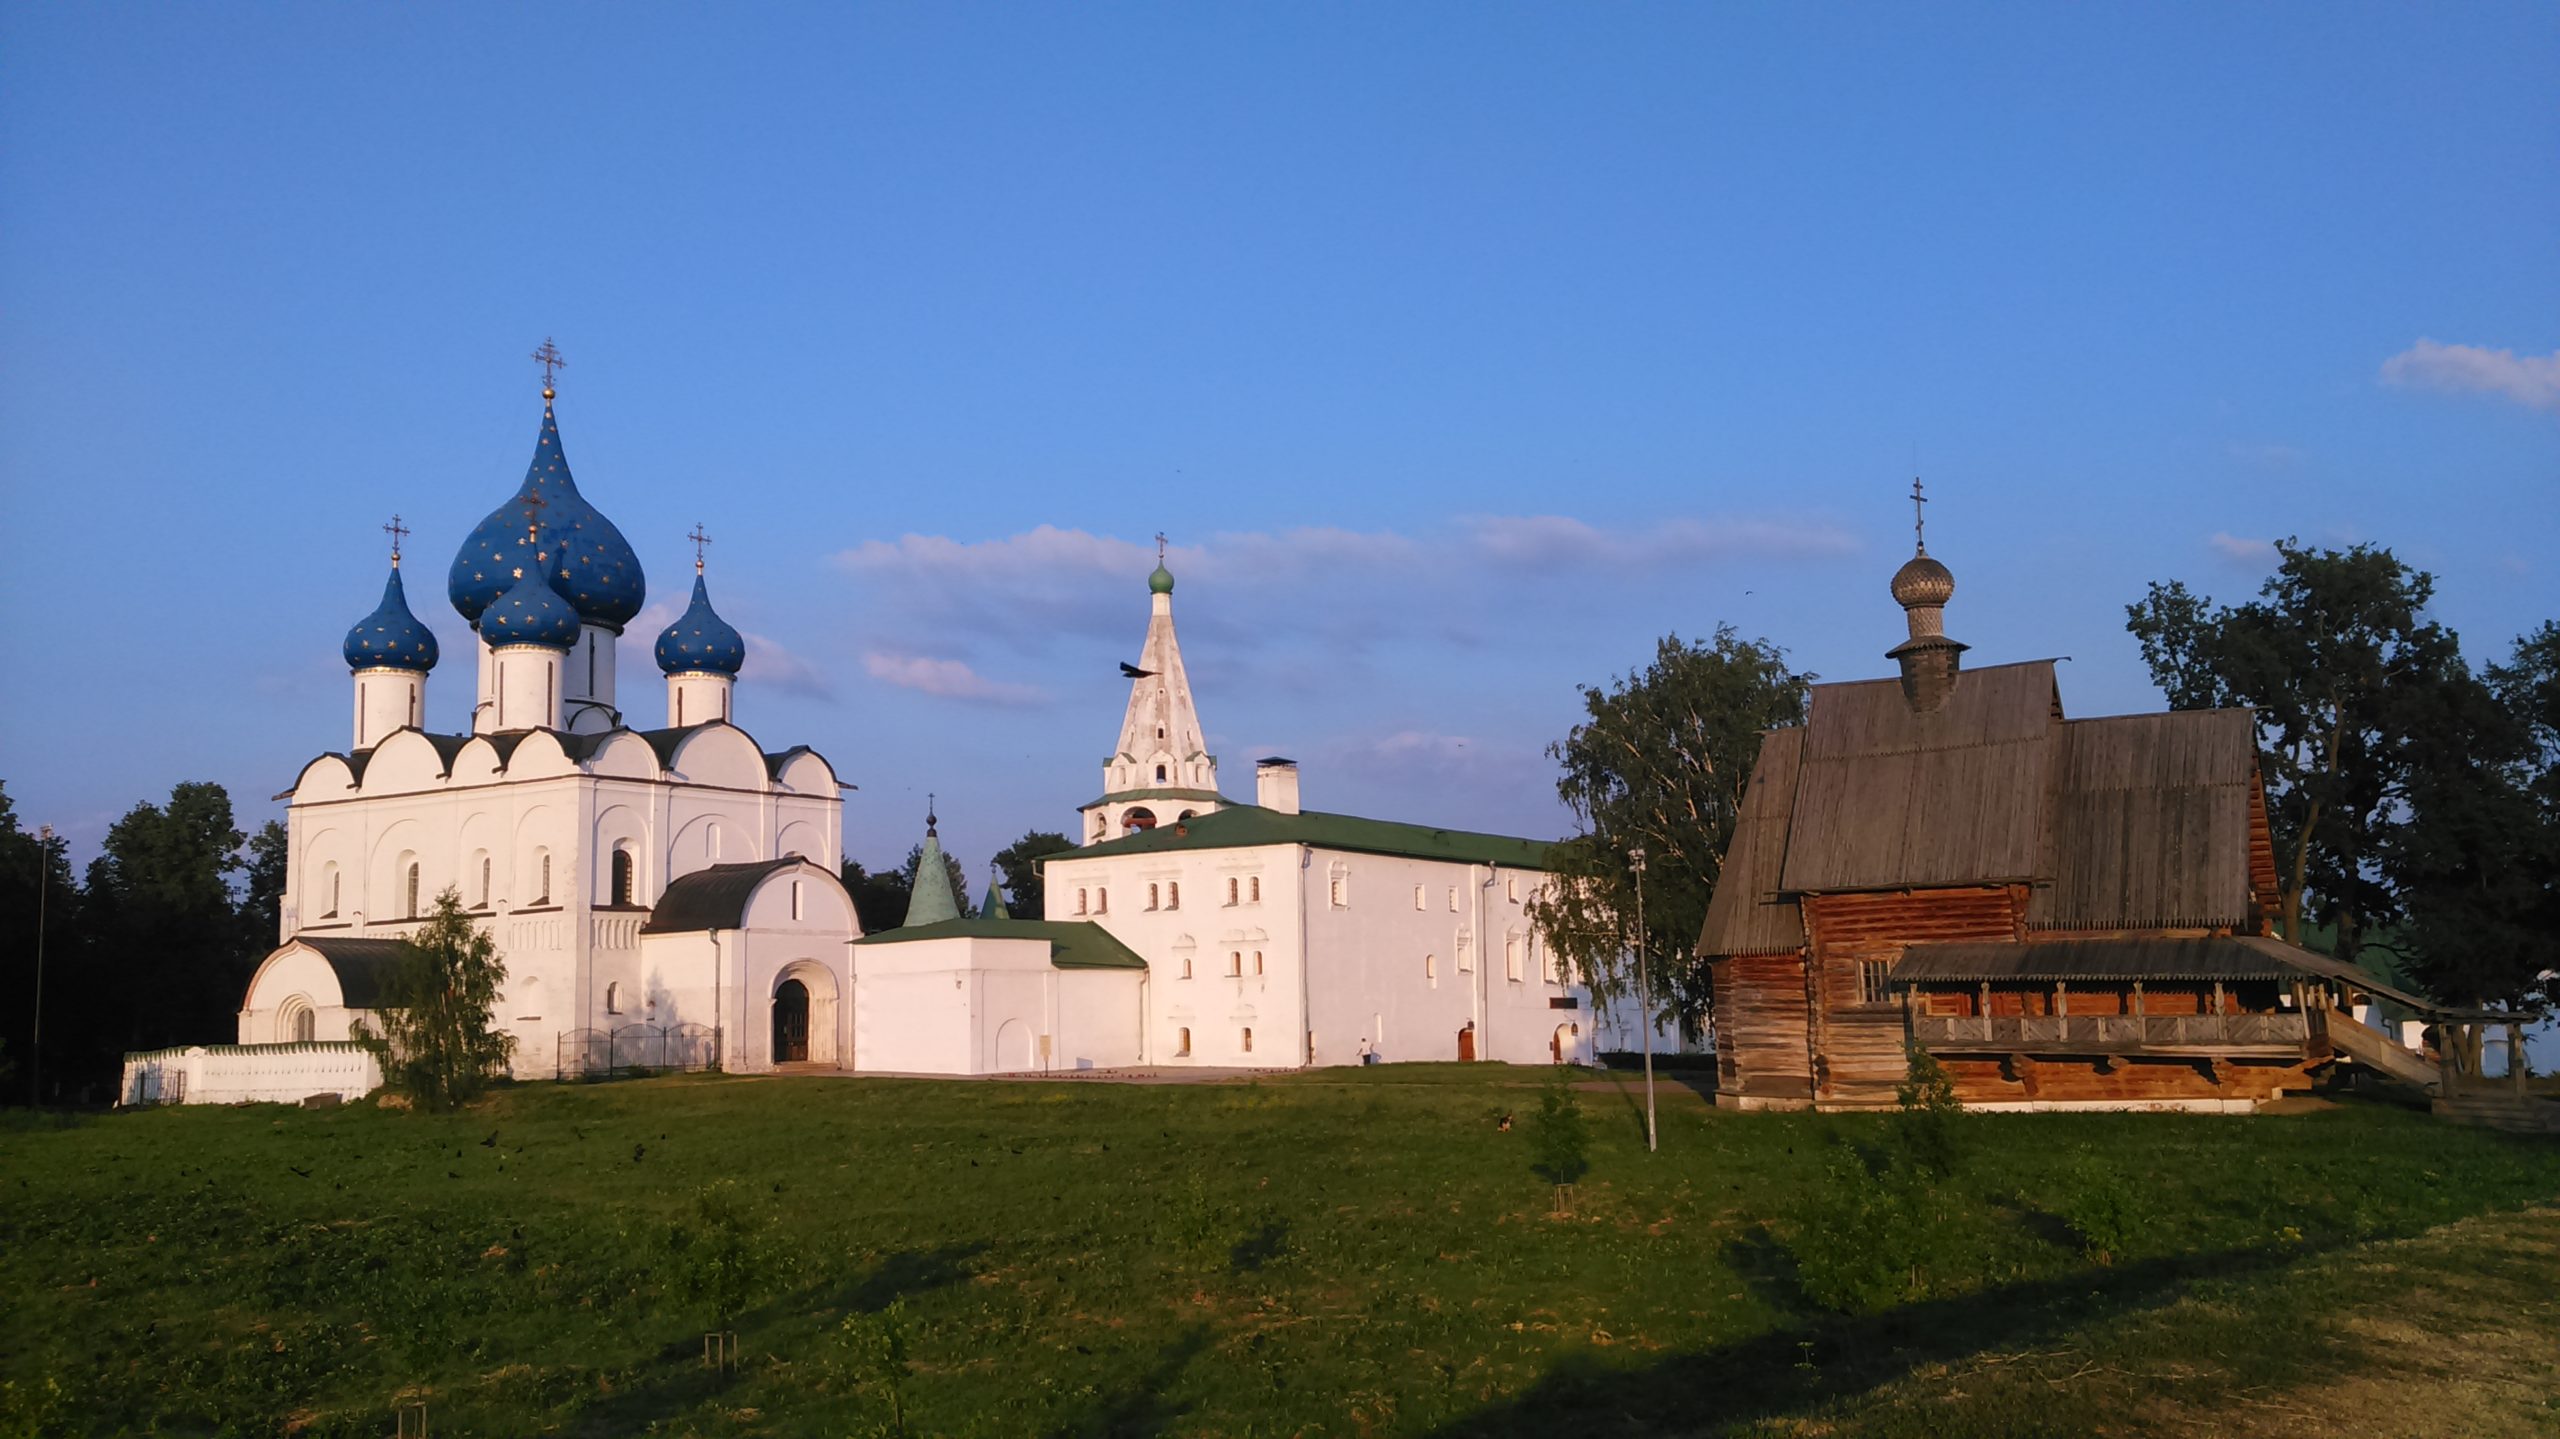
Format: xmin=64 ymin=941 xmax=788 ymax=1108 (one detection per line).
xmin=0 ymin=5 xmax=2560 ymax=863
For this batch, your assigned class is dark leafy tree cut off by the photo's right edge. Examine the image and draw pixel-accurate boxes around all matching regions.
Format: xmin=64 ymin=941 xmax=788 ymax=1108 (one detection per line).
xmin=2383 ymin=622 xmax=2560 ymax=1006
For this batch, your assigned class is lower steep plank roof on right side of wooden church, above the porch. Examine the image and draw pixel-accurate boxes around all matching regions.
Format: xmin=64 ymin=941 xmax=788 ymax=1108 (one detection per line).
xmin=2028 ymin=709 xmax=2258 ymax=929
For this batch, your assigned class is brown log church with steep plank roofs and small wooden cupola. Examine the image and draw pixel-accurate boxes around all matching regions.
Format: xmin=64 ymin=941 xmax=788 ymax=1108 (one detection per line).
xmin=1697 ymin=501 xmax=2396 ymax=1109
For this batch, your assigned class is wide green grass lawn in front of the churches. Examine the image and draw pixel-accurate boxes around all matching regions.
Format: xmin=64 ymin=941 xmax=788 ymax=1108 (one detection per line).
xmin=0 ymin=1065 xmax=2560 ymax=1439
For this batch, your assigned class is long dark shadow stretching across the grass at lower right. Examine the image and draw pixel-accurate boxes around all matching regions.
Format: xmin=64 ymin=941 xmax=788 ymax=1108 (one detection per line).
xmin=1436 ymin=1232 xmax=2322 ymax=1439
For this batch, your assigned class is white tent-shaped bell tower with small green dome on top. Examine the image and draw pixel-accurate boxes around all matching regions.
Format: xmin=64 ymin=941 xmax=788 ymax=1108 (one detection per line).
xmin=1080 ymin=535 xmax=1224 ymax=845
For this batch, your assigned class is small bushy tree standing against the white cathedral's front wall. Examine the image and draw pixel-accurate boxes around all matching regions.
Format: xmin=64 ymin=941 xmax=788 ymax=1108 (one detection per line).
xmin=356 ymin=886 xmax=515 ymax=1109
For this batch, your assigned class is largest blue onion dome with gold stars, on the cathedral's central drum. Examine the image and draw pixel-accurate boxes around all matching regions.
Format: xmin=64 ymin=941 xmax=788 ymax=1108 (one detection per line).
xmin=445 ymin=392 xmax=648 ymax=638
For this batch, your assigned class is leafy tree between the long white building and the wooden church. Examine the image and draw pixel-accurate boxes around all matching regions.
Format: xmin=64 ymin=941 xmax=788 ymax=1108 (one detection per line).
xmin=1536 ymin=625 xmax=1812 ymax=1034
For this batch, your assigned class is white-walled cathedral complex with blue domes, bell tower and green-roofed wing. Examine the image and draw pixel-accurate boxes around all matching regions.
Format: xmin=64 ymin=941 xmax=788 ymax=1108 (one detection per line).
xmin=154 ymin=371 xmax=1595 ymax=1101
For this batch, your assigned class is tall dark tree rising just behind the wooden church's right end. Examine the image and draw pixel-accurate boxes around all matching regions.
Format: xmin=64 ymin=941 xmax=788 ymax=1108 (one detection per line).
xmin=2125 ymin=540 xmax=2463 ymax=963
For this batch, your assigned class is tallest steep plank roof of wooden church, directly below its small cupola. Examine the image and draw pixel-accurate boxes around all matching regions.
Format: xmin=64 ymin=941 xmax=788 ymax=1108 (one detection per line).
xmin=1779 ymin=661 xmax=2058 ymax=894
